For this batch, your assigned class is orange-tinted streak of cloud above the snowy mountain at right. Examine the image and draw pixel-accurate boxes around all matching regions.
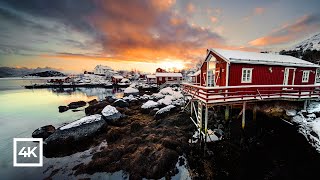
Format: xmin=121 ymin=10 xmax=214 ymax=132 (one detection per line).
xmin=249 ymin=15 xmax=320 ymax=46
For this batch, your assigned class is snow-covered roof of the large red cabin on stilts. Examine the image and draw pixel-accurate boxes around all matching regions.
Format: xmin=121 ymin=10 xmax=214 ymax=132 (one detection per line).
xmin=211 ymin=49 xmax=320 ymax=67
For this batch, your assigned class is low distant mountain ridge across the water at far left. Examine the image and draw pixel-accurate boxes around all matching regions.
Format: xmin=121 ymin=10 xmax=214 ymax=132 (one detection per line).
xmin=0 ymin=67 xmax=62 ymax=77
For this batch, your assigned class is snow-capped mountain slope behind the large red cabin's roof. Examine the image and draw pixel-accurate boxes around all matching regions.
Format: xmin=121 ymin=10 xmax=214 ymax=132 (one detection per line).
xmin=291 ymin=33 xmax=320 ymax=51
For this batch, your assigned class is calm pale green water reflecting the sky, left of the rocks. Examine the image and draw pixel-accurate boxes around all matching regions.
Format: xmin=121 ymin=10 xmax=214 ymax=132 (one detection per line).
xmin=0 ymin=79 xmax=124 ymax=174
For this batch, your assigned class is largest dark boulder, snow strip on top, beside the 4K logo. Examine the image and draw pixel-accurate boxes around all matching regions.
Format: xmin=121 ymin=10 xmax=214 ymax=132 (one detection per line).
xmin=43 ymin=114 xmax=107 ymax=157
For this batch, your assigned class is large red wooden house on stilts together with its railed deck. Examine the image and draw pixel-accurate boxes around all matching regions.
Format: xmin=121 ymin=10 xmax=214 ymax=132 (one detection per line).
xmin=185 ymin=49 xmax=320 ymax=102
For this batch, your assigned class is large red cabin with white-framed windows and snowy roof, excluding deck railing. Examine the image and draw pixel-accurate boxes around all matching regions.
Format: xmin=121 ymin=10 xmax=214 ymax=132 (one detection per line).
xmin=200 ymin=49 xmax=319 ymax=87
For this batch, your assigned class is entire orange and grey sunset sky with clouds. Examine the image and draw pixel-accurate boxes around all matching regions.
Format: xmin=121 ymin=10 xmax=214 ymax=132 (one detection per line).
xmin=0 ymin=0 xmax=320 ymax=72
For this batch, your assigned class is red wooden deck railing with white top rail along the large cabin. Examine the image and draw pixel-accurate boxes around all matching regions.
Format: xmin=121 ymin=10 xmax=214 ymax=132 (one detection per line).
xmin=182 ymin=83 xmax=320 ymax=103
